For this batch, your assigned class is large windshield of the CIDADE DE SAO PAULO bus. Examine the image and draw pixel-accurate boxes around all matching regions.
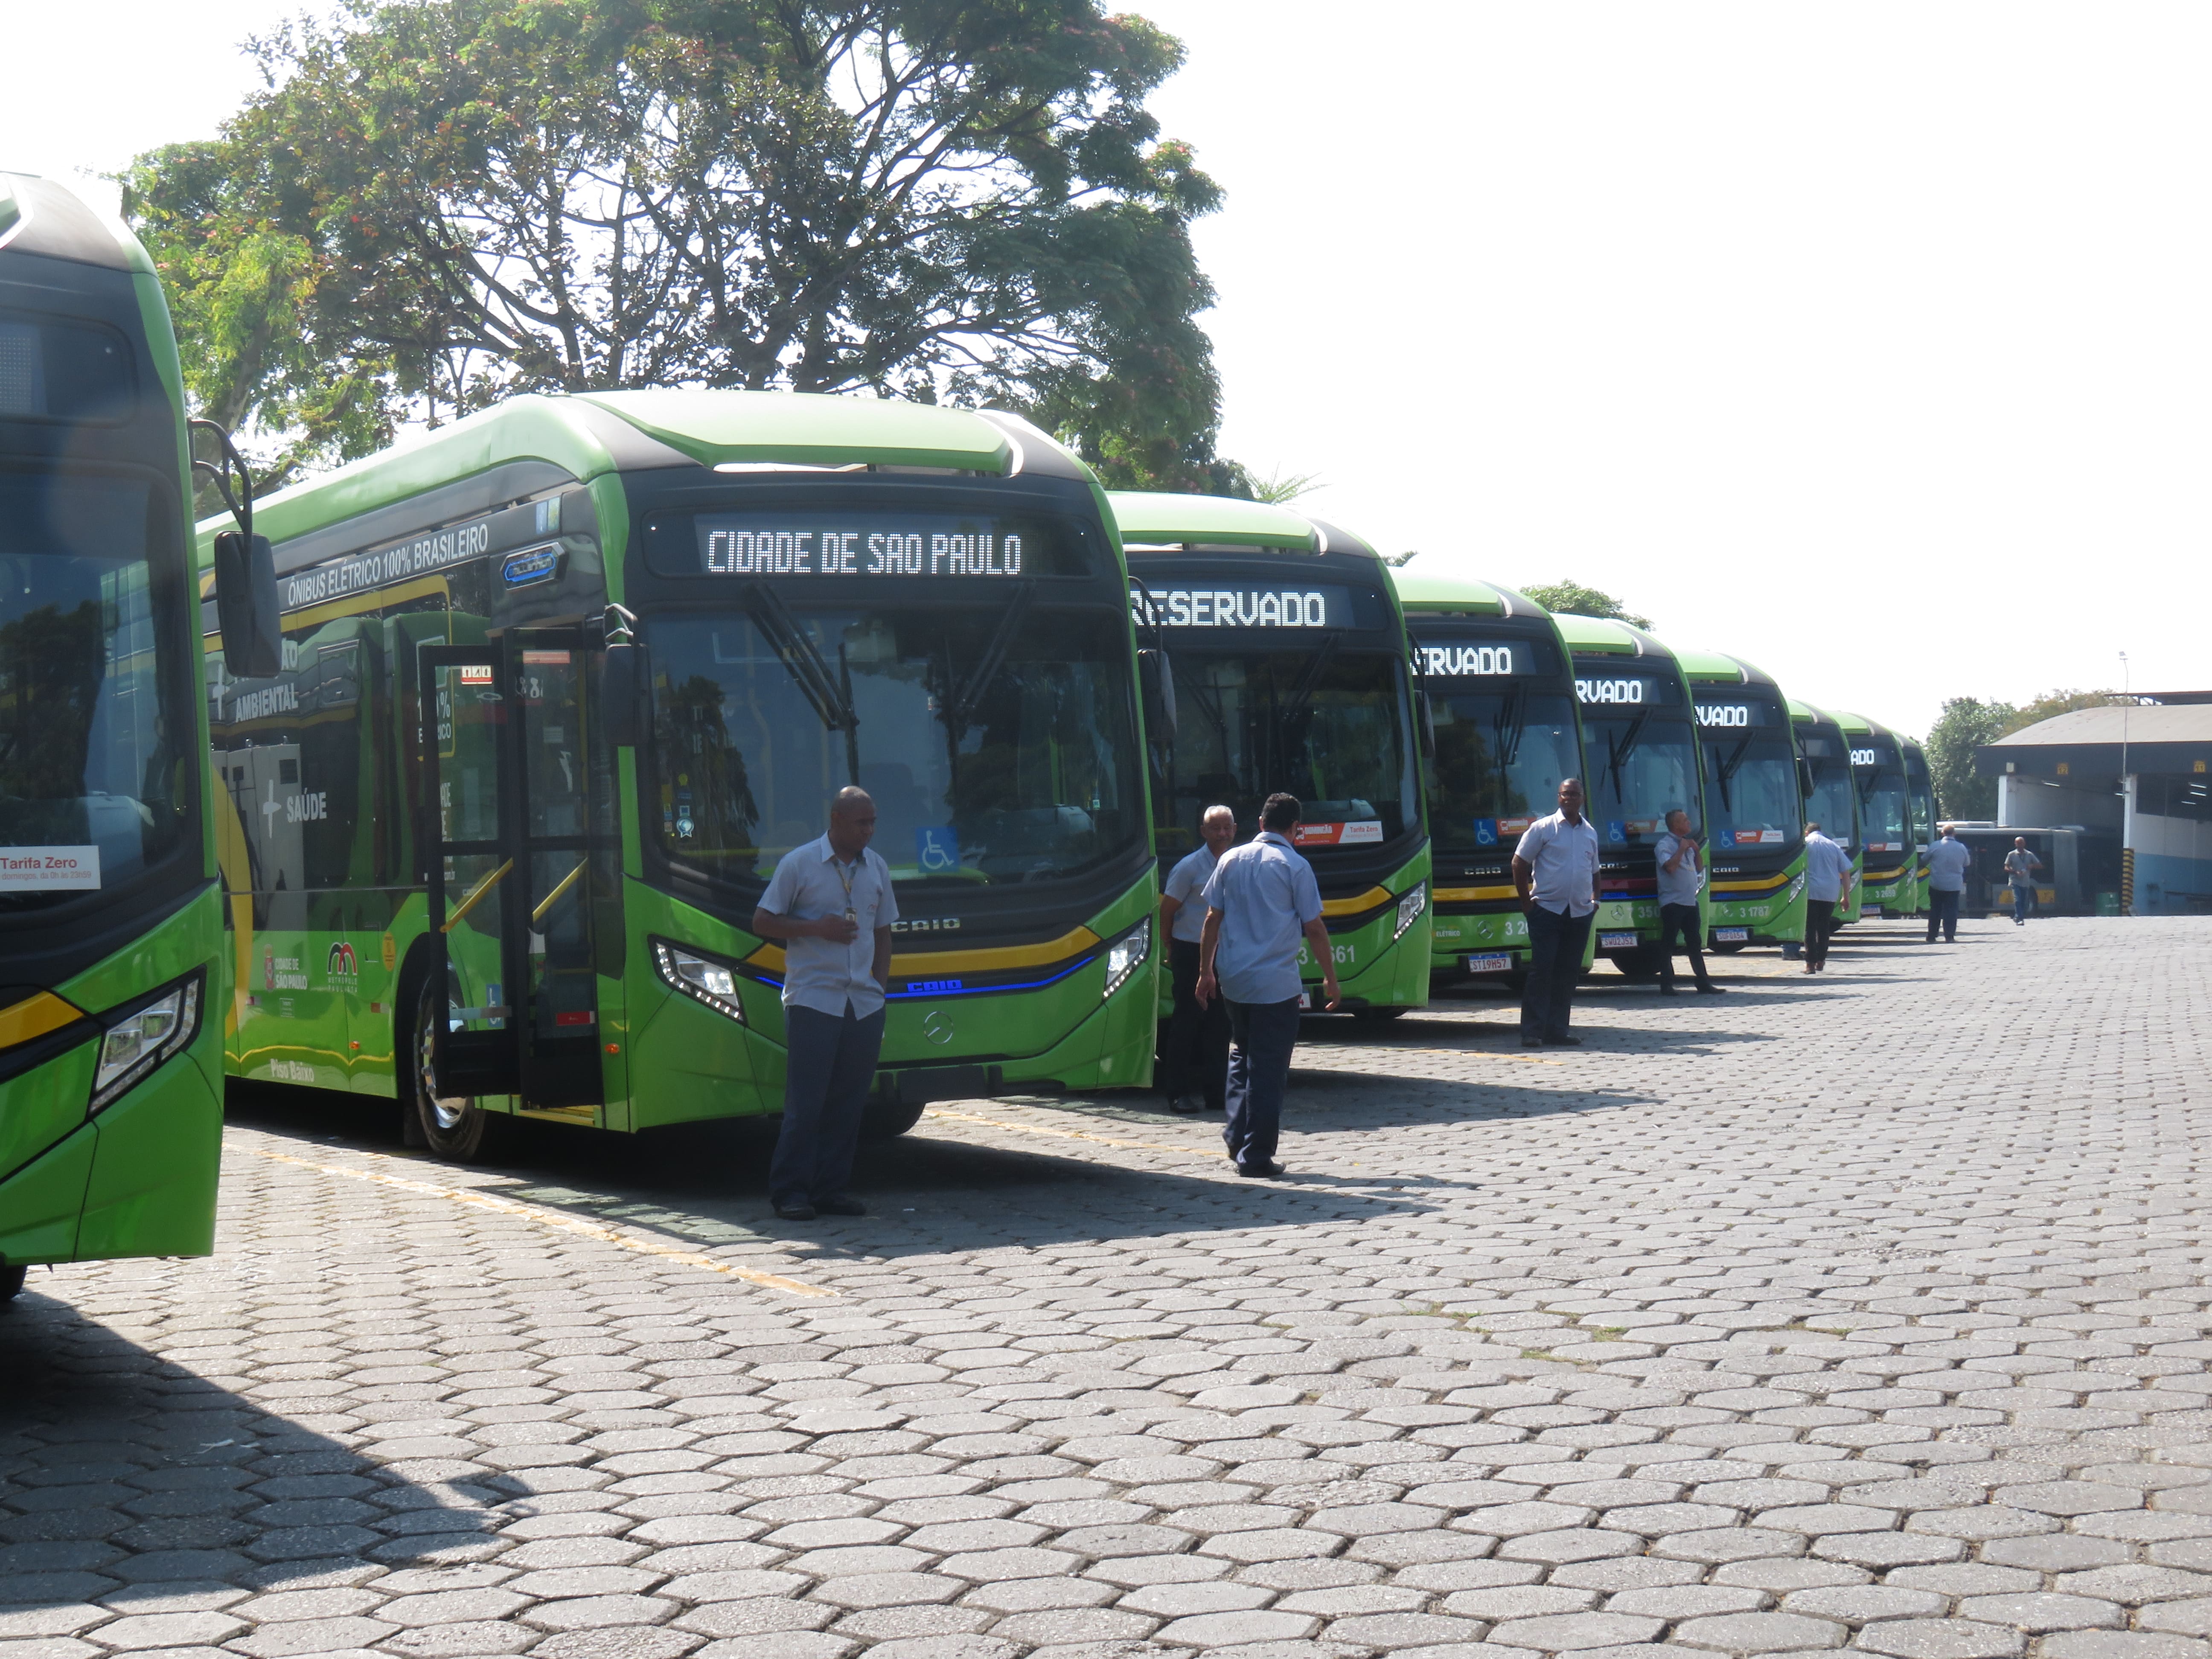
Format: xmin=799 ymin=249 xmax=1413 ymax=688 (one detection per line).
xmin=648 ymin=604 xmax=1144 ymax=891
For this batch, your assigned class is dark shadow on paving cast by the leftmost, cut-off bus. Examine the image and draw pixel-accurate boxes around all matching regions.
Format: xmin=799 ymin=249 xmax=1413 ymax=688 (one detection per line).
xmin=0 ymin=1274 xmax=506 ymax=1601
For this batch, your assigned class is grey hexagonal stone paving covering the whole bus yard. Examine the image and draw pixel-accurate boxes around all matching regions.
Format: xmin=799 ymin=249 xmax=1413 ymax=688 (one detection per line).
xmin=0 ymin=920 xmax=2212 ymax=1659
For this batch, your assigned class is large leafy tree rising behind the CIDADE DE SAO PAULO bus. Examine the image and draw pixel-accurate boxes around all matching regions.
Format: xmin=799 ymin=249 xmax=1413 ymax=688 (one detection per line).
xmin=124 ymin=0 xmax=1250 ymax=493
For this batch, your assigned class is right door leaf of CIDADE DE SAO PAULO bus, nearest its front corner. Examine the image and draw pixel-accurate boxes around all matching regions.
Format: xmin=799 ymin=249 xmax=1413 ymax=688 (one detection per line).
xmin=509 ymin=628 xmax=615 ymax=1121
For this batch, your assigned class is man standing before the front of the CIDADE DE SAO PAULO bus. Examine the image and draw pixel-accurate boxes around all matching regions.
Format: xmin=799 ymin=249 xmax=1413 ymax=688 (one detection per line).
xmin=752 ymin=790 xmax=898 ymax=1221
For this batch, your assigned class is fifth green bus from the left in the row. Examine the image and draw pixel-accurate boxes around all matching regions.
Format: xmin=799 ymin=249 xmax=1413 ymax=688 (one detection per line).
xmin=1557 ymin=615 xmax=1712 ymax=973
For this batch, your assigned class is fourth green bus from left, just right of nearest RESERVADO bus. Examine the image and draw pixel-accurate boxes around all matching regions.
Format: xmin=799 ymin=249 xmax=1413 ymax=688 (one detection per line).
xmin=1391 ymin=570 xmax=1584 ymax=984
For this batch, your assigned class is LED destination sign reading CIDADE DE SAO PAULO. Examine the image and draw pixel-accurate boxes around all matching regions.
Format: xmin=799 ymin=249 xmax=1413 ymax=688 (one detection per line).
xmin=681 ymin=511 xmax=1084 ymax=579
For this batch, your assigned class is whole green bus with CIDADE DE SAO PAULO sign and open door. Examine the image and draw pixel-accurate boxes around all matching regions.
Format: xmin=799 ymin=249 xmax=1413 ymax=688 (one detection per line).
xmin=206 ymin=392 xmax=1159 ymax=1159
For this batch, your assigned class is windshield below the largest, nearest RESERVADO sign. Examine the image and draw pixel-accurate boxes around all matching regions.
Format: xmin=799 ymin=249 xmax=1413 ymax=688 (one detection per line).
xmin=1153 ymin=646 xmax=1420 ymax=856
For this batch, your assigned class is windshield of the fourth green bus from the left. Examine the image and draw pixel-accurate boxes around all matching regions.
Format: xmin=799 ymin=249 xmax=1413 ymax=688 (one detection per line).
xmin=1429 ymin=679 xmax=1582 ymax=854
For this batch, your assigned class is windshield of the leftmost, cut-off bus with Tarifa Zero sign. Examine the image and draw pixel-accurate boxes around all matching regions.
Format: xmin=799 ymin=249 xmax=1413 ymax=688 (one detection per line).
xmin=0 ymin=471 xmax=201 ymax=916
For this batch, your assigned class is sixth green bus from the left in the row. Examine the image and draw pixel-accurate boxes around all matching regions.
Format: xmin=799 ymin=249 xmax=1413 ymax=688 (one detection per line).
xmin=1679 ymin=650 xmax=1805 ymax=951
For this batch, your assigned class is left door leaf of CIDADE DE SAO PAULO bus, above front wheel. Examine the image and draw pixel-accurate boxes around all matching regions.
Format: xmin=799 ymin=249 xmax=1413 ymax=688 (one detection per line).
xmin=420 ymin=644 xmax=522 ymax=1095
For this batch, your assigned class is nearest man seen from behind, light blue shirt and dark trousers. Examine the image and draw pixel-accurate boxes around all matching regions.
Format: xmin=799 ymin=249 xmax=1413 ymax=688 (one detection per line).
xmin=1199 ymin=794 xmax=1338 ymax=1177
